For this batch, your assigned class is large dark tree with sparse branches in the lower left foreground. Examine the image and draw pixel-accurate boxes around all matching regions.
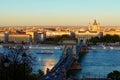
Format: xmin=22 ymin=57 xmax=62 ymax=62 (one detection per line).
xmin=0 ymin=45 xmax=43 ymax=80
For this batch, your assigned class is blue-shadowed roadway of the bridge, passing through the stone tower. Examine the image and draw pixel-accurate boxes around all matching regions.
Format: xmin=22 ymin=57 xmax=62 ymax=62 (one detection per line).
xmin=38 ymin=44 xmax=82 ymax=80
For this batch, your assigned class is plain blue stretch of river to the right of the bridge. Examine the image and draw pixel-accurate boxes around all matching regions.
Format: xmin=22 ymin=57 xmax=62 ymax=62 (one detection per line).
xmin=76 ymin=49 xmax=120 ymax=78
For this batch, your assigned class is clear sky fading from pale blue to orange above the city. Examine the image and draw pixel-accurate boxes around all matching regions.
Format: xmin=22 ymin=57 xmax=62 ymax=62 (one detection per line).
xmin=0 ymin=0 xmax=120 ymax=26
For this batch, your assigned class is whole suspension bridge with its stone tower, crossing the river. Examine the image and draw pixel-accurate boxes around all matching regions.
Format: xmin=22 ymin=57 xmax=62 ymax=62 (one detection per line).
xmin=38 ymin=41 xmax=83 ymax=80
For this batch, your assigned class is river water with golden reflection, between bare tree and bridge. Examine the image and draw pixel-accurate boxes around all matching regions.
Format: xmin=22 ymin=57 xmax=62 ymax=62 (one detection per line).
xmin=30 ymin=50 xmax=62 ymax=74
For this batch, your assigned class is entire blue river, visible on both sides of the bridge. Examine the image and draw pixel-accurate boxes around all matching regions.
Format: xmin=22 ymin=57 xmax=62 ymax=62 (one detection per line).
xmin=0 ymin=45 xmax=120 ymax=78
